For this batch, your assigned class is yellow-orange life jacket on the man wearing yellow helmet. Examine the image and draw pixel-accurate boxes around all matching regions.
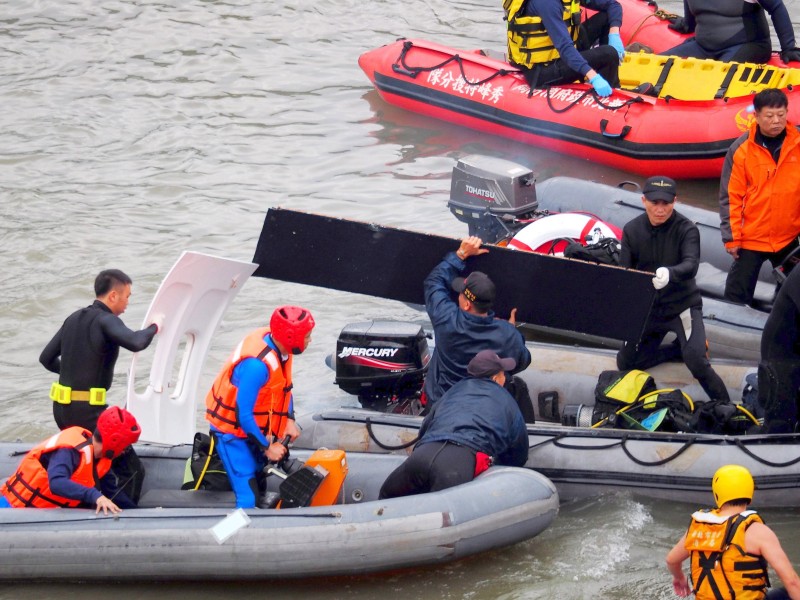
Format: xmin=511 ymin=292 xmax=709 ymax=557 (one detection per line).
xmin=686 ymin=510 xmax=769 ymax=600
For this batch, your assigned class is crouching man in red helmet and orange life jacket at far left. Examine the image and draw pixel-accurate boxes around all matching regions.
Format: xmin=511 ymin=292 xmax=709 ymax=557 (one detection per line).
xmin=0 ymin=406 xmax=142 ymax=515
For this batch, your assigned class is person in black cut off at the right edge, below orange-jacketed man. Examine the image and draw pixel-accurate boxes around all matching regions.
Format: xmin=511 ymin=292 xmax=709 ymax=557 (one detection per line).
xmin=758 ymin=269 xmax=800 ymax=433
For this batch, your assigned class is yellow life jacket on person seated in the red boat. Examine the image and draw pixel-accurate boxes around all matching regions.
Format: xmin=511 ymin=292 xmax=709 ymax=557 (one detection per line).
xmin=503 ymin=0 xmax=581 ymax=69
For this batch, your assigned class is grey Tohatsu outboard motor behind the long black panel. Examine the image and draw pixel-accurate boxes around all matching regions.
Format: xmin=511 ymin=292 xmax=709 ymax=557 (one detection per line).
xmin=447 ymin=154 xmax=539 ymax=243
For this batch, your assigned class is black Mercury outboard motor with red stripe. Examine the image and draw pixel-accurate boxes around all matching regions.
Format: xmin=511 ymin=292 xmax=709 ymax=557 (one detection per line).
xmin=334 ymin=321 xmax=431 ymax=414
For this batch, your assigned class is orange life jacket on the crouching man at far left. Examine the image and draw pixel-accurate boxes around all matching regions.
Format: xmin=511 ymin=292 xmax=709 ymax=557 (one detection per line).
xmin=0 ymin=427 xmax=111 ymax=508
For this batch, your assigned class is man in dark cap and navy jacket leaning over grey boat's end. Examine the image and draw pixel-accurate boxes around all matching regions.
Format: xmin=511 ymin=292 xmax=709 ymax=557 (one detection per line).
xmin=380 ymin=350 xmax=528 ymax=499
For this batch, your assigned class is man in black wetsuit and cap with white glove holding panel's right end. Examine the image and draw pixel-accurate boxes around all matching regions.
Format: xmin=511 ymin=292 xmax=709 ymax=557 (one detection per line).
xmin=617 ymin=176 xmax=730 ymax=401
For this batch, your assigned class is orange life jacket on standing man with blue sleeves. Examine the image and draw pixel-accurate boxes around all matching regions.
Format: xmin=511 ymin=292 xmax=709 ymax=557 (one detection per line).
xmin=206 ymin=328 xmax=292 ymax=439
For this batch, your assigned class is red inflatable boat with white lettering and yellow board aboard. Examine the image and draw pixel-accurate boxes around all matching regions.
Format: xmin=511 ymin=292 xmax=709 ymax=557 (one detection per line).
xmin=358 ymin=37 xmax=800 ymax=179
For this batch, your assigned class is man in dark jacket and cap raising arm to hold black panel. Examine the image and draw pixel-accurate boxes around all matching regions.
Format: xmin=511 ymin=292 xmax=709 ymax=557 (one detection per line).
xmin=418 ymin=236 xmax=531 ymax=410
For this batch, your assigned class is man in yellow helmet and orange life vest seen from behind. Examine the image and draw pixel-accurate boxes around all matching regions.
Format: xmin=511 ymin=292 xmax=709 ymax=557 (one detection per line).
xmin=667 ymin=465 xmax=800 ymax=600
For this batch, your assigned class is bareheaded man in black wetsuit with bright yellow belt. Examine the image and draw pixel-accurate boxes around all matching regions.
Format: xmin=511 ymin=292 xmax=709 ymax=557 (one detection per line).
xmin=39 ymin=269 xmax=161 ymax=431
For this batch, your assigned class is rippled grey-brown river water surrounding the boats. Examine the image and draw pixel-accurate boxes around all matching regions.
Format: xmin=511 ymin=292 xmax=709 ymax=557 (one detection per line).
xmin=0 ymin=0 xmax=800 ymax=600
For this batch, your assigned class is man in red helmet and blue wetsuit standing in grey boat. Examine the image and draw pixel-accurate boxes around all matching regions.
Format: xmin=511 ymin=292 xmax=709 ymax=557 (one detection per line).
xmin=206 ymin=306 xmax=314 ymax=508
